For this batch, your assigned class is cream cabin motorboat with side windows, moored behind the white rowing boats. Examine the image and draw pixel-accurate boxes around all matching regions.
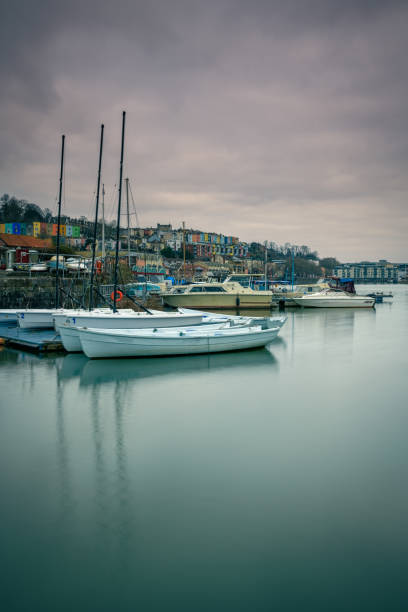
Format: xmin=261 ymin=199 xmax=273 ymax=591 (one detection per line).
xmin=162 ymin=279 xmax=273 ymax=310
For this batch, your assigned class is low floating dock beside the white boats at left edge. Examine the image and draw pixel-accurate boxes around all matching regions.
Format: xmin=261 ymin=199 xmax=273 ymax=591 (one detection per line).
xmin=0 ymin=324 xmax=64 ymax=353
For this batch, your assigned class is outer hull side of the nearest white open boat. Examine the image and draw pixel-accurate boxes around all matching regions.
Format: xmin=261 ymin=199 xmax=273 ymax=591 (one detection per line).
xmin=79 ymin=328 xmax=279 ymax=359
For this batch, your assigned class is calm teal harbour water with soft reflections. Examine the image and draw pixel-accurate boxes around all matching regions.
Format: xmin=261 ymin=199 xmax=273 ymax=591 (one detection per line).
xmin=0 ymin=286 xmax=408 ymax=612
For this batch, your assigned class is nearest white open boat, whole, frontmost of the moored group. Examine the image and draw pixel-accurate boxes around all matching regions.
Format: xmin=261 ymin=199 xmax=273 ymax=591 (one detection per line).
xmin=78 ymin=325 xmax=279 ymax=359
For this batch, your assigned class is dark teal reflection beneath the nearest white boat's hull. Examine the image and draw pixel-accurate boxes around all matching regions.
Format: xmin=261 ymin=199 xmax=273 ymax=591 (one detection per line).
xmin=77 ymin=349 xmax=278 ymax=387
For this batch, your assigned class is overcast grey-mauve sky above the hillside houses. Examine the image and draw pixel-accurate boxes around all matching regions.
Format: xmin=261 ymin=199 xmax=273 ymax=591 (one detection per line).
xmin=0 ymin=0 xmax=408 ymax=262
